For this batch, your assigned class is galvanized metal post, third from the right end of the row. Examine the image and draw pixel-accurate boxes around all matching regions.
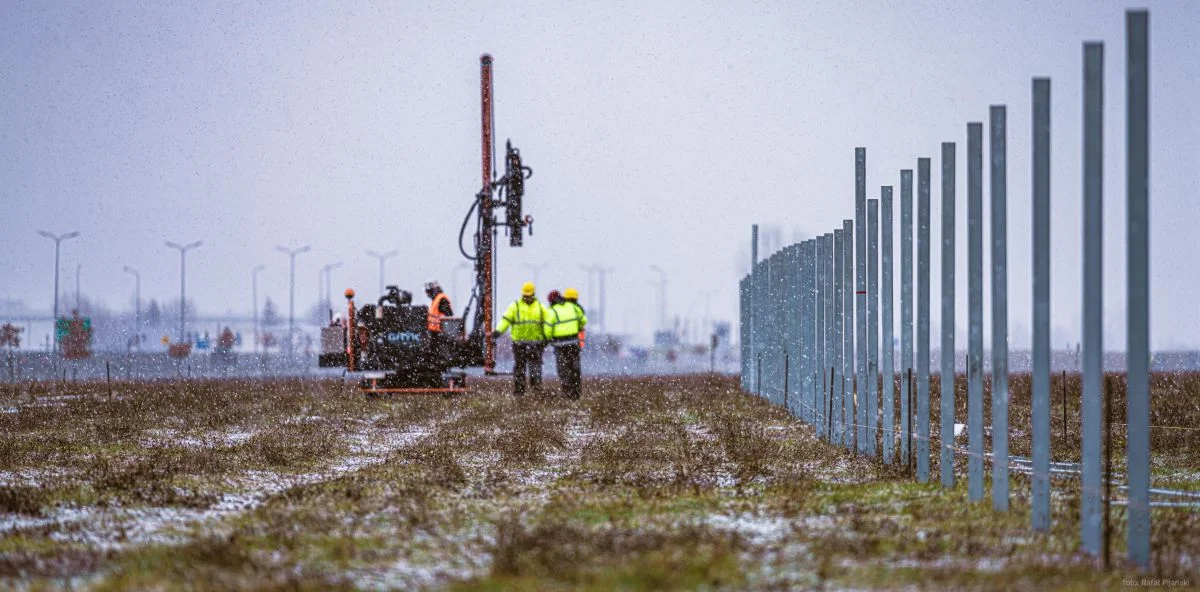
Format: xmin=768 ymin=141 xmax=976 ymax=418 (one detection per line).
xmin=1031 ymin=78 xmax=1050 ymax=532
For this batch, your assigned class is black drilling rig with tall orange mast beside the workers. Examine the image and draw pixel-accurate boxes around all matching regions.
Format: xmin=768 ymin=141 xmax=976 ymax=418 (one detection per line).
xmin=318 ymin=54 xmax=533 ymax=396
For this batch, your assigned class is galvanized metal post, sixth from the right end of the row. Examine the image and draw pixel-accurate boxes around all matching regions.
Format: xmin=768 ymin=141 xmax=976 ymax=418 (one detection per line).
xmin=940 ymin=142 xmax=955 ymax=489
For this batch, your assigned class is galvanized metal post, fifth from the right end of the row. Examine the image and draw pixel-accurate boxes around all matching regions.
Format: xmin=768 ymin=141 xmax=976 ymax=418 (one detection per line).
xmin=967 ymin=122 xmax=984 ymax=502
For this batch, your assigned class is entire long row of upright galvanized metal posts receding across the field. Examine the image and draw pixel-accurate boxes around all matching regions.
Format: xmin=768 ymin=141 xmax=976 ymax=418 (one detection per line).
xmin=739 ymin=11 xmax=1150 ymax=567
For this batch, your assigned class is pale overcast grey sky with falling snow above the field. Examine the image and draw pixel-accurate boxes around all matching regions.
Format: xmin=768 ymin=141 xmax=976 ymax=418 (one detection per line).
xmin=0 ymin=0 xmax=1200 ymax=348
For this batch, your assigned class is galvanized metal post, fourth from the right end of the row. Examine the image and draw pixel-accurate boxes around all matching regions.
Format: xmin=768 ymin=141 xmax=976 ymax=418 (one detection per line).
xmin=988 ymin=104 xmax=1008 ymax=512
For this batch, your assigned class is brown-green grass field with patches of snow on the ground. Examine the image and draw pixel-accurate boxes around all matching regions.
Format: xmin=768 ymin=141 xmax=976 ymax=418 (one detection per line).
xmin=0 ymin=377 xmax=1200 ymax=590
